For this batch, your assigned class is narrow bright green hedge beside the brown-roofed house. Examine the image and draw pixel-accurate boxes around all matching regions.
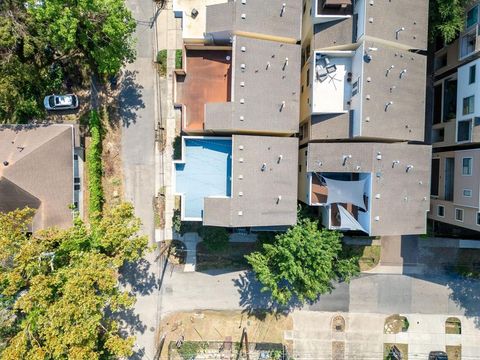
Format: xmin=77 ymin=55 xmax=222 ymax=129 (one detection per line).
xmin=87 ymin=110 xmax=104 ymax=220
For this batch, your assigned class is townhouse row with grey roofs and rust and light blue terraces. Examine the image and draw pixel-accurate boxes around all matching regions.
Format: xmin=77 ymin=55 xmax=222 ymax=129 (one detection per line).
xmin=173 ymin=0 xmax=301 ymax=229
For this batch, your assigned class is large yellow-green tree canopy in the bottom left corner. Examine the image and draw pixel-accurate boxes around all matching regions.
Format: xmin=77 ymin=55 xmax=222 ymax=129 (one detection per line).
xmin=0 ymin=204 xmax=147 ymax=360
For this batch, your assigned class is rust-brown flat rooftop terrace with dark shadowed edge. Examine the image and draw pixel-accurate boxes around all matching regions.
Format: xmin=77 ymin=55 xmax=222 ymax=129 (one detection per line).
xmin=177 ymin=50 xmax=232 ymax=131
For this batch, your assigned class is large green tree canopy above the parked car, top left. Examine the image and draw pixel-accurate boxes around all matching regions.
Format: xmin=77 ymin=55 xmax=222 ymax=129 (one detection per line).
xmin=0 ymin=0 xmax=136 ymax=122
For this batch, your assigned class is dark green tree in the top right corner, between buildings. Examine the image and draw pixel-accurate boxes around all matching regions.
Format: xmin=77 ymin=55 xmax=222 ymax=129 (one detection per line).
xmin=430 ymin=0 xmax=469 ymax=43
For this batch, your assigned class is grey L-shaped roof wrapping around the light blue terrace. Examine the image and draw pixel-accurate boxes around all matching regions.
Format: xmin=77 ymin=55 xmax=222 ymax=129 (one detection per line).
xmin=203 ymin=135 xmax=298 ymax=227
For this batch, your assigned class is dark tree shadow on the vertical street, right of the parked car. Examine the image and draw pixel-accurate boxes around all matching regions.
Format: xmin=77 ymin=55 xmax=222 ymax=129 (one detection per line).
xmin=118 ymin=70 xmax=145 ymax=127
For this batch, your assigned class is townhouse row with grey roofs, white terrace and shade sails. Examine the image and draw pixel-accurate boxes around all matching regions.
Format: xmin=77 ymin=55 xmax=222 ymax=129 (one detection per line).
xmin=299 ymin=0 xmax=431 ymax=236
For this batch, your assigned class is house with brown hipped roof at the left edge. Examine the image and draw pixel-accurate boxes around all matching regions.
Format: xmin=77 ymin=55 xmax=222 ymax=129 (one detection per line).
xmin=0 ymin=124 xmax=82 ymax=230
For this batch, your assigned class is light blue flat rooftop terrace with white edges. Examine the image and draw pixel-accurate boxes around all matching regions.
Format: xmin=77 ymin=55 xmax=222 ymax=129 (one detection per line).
xmin=175 ymin=137 xmax=232 ymax=220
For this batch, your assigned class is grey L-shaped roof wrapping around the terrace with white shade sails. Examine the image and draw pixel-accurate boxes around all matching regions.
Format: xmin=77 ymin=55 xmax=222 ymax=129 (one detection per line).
xmin=306 ymin=143 xmax=431 ymax=236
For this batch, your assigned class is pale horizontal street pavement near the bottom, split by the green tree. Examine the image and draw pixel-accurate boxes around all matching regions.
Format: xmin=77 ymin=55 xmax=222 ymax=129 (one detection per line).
xmin=162 ymin=265 xmax=480 ymax=322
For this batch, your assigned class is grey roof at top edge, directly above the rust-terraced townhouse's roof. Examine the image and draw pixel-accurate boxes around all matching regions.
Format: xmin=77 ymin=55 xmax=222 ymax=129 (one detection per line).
xmin=206 ymin=0 xmax=302 ymax=42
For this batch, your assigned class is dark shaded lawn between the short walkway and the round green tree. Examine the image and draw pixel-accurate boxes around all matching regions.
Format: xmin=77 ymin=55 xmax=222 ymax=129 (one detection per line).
xmin=196 ymin=242 xmax=256 ymax=271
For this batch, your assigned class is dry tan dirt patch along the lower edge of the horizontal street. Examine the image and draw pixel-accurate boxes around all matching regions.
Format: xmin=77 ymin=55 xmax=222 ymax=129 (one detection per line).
xmin=157 ymin=311 xmax=293 ymax=359
